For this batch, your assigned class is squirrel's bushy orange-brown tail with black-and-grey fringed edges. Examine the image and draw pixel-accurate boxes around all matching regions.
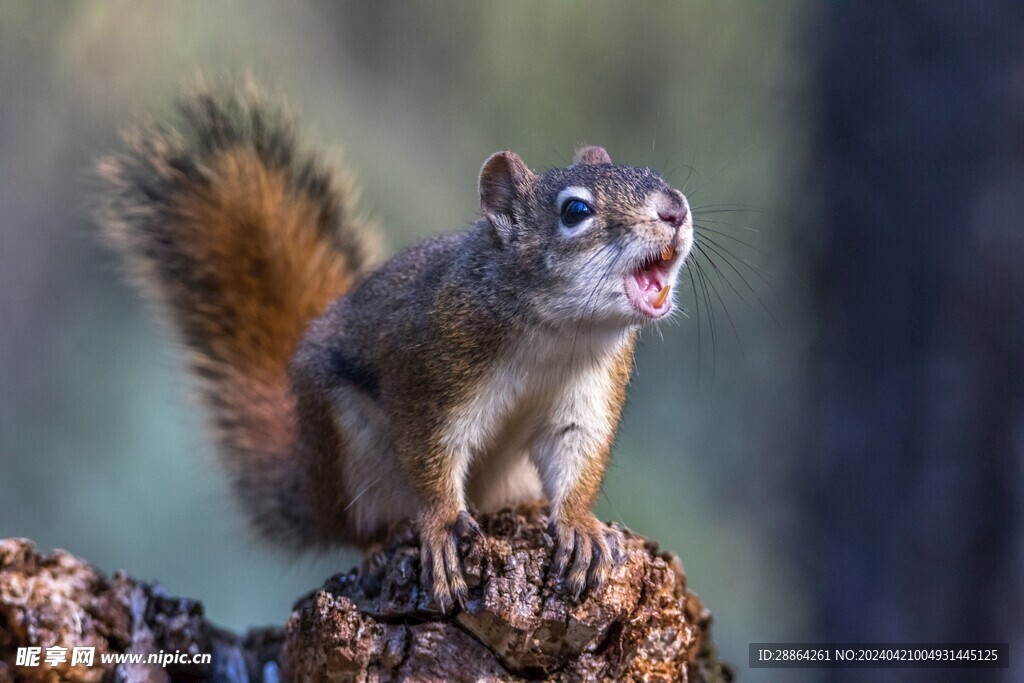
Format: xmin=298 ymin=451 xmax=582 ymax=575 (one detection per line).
xmin=98 ymin=89 xmax=372 ymax=545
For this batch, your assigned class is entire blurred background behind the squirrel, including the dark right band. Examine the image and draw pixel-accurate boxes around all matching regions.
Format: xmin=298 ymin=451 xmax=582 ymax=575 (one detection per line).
xmin=0 ymin=0 xmax=1024 ymax=681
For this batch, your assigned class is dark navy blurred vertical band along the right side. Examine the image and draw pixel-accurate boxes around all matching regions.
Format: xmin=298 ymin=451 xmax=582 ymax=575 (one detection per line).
xmin=798 ymin=2 xmax=1024 ymax=681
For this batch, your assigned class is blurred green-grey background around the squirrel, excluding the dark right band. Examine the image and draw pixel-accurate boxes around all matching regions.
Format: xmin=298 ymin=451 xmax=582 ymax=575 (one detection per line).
xmin=6 ymin=0 xmax=1015 ymax=680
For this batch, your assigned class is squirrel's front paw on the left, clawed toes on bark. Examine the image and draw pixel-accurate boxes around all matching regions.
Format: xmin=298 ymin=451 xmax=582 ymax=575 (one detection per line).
xmin=420 ymin=510 xmax=483 ymax=612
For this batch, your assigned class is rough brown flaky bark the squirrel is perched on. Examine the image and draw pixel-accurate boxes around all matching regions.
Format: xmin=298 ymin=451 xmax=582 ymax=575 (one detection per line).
xmin=0 ymin=507 xmax=731 ymax=683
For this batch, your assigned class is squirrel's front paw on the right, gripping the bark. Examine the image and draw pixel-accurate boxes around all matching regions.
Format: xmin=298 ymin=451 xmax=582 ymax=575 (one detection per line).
xmin=551 ymin=513 xmax=623 ymax=600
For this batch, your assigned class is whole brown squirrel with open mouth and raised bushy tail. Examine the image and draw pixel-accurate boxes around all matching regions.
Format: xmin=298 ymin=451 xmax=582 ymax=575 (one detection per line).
xmin=97 ymin=87 xmax=693 ymax=610
